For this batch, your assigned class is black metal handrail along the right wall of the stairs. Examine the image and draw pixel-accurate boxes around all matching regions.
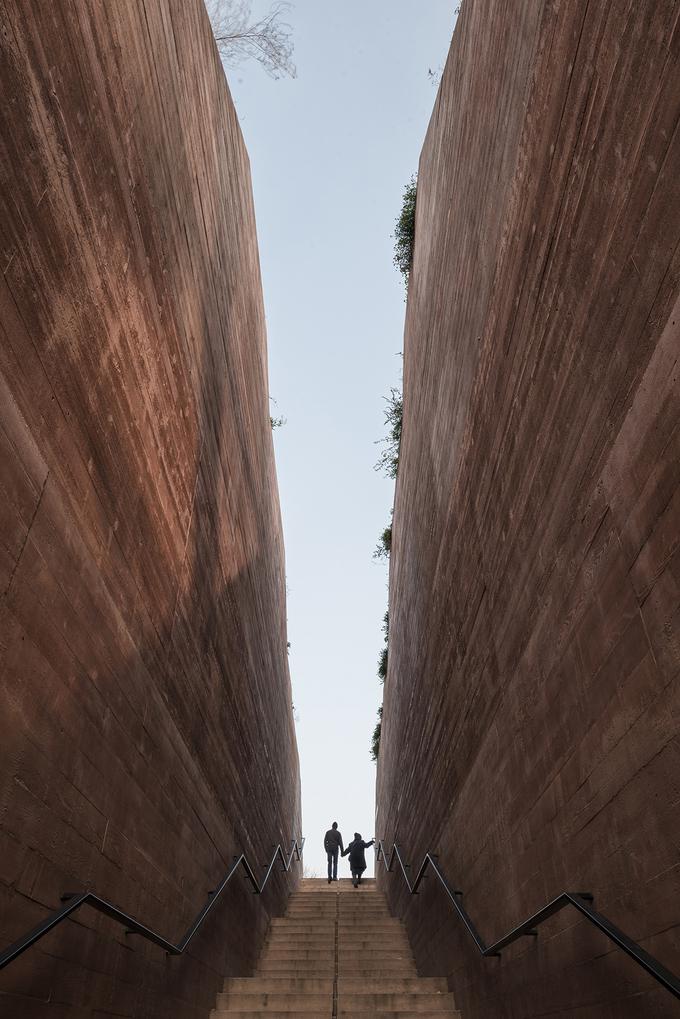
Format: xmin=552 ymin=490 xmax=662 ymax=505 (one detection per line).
xmin=376 ymin=840 xmax=680 ymax=998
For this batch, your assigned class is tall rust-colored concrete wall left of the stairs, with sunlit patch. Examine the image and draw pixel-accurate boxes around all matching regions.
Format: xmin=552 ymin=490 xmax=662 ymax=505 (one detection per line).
xmin=0 ymin=0 xmax=300 ymax=1019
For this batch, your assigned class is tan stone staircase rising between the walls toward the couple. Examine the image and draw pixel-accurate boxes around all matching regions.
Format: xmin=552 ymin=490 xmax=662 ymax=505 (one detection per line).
xmin=213 ymin=879 xmax=460 ymax=1019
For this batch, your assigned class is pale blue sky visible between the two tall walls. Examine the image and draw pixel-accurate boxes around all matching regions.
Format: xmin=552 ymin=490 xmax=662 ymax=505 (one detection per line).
xmin=227 ymin=0 xmax=457 ymax=877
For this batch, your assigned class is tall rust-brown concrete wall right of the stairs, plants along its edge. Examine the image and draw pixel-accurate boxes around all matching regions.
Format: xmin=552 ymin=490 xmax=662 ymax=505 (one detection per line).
xmin=377 ymin=0 xmax=680 ymax=1019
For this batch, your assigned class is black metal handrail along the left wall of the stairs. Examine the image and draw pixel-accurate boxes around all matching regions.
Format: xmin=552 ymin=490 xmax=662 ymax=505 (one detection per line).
xmin=0 ymin=839 xmax=305 ymax=969
